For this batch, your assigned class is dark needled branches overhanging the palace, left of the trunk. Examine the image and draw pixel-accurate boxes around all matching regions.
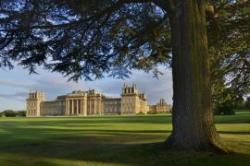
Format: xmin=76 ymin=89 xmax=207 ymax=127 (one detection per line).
xmin=0 ymin=0 xmax=171 ymax=80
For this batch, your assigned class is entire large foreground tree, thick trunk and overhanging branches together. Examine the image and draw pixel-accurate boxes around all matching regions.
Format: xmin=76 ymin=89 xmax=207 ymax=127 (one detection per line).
xmin=0 ymin=0 xmax=250 ymax=150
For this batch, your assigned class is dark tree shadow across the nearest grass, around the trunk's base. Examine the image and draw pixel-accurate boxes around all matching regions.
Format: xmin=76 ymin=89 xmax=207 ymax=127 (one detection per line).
xmin=0 ymin=135 xmax=250 ymax=166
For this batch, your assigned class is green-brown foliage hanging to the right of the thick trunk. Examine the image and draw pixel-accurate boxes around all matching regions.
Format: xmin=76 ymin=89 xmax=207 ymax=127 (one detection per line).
xmin=208 ymin=0 xmax=250 ymax=106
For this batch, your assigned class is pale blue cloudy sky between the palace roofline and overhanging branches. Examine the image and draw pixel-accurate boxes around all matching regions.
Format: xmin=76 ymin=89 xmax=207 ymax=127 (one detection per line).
xmin=0 ymin=66 xmax=173 ymax=111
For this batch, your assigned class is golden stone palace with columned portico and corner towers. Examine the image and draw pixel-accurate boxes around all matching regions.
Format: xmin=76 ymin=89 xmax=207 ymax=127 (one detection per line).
xmin=26 ymin=84 xmax=149 ymax=117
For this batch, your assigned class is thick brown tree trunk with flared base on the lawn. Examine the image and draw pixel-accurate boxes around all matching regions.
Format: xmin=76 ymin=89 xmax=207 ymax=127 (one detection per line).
xmin=167 ymin=0 xmax=228 ymax=150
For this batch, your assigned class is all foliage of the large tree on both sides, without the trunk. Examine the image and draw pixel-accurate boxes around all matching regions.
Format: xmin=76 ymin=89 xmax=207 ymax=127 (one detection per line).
xmin=0 ymin=0 xmax=250 ymax=82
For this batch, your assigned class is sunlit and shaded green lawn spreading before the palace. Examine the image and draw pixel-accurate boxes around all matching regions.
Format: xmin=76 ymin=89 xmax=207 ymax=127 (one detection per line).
xmin=0 ymin=111 xmax=250 ymax=166
